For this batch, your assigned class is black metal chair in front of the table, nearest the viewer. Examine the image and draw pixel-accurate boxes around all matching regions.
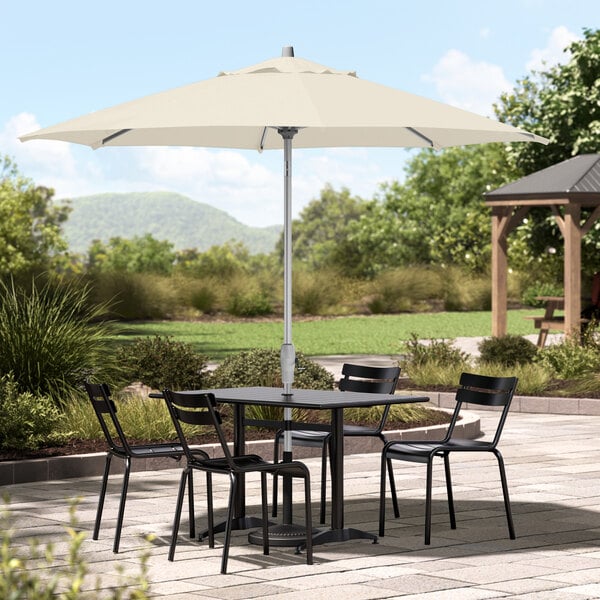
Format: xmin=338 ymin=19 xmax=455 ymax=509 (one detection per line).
xmin=163 ymin=390 xmax=313 ymax=573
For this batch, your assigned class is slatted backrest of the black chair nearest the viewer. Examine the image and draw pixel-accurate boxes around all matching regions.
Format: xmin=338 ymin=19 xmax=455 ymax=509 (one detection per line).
xmin=163 ymin=390 xmax=236 ymax=470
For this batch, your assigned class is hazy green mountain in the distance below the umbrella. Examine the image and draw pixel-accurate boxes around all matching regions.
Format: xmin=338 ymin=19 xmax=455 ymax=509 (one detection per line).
xmin=63 ymin=192 xmax=282 ymax=254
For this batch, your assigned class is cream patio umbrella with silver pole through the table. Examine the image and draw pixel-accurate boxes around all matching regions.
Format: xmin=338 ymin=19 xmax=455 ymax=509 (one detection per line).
xmin=20 ymin=47 xmax=547 ymax=540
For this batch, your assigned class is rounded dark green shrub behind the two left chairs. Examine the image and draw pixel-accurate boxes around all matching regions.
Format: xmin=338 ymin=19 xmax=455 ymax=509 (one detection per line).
xmin=118 ymin=335 xmax=207 ymax=390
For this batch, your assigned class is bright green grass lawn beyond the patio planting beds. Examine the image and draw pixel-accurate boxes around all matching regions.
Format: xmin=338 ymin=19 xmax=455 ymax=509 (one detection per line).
xmin=115 ymin=309 xmax=540 ymax=361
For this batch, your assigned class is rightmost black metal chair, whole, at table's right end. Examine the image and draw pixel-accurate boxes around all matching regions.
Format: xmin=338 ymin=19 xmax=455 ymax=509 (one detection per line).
xmin=379 ymin=373 xmax=518 ymax=544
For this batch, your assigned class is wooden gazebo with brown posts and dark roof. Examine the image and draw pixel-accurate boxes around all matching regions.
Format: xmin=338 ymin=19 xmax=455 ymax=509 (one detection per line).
xmin=485 ymin=154 xmax=600 ymax=336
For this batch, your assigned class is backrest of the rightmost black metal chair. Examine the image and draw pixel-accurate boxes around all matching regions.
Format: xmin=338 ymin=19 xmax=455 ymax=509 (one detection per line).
xmin=446 ymin=373 xmax=518 ymax=447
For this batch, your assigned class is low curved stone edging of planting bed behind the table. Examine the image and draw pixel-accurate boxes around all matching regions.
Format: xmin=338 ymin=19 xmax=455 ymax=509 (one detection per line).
xmin=0 ymin=407 xmax=481 ymax=486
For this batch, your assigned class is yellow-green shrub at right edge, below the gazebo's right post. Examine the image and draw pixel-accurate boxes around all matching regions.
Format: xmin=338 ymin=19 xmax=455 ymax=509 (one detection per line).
xmin=536 ymin=339 xmax=600 ymax=379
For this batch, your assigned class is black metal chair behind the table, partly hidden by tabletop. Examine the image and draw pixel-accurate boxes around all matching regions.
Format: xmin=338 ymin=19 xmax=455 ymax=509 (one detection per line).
xmin=273 ymin=363 xmax=400 ymax=523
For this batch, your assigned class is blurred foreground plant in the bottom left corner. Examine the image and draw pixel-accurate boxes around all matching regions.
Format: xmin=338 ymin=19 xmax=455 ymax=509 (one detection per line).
xmin=0 ymin=497 xmax=150 ymax=600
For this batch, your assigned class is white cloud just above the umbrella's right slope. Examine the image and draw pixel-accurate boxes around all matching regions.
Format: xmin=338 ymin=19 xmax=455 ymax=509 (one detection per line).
xmin=423 ymin=49 xmax=512 ymax=116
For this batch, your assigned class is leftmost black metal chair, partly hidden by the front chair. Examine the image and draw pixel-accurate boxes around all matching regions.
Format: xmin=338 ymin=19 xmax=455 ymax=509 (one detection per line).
xmin=84 ymin=382 xmax=208 ymax=553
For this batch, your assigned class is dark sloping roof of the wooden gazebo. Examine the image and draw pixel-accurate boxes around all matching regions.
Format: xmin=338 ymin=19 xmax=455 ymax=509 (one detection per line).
xmin=485 ymin=154 xmax=600 ymax=202
